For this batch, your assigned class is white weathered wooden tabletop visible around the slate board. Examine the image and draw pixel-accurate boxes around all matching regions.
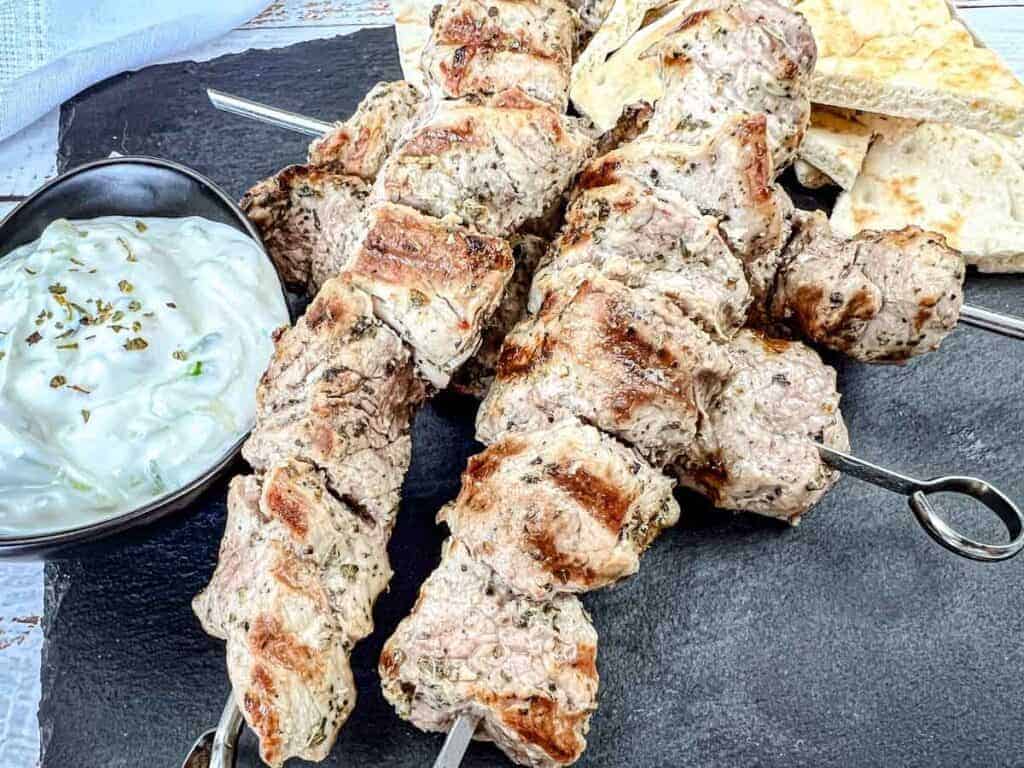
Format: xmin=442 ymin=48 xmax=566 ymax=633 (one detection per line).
xmin=0 ymin=0 xmax=1024 ymax=768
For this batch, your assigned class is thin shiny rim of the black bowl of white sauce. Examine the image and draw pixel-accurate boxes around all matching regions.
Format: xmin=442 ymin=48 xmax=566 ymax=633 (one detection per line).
xmin=0 ymin=155 xmax=293 ymax=558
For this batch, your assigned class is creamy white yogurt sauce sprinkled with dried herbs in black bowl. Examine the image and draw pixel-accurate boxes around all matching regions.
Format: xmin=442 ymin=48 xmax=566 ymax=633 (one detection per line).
xmin=0 ymin=216 xmax=288 ymax=536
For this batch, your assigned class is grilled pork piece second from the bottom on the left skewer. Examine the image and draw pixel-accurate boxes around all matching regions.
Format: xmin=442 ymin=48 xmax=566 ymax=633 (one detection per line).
xmin=242 ymin=279 xmax=423 ymax=530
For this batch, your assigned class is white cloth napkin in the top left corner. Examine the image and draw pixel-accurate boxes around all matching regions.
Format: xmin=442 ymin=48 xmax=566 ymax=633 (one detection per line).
xmin=0 ymin=0 xmax=268 ymax=140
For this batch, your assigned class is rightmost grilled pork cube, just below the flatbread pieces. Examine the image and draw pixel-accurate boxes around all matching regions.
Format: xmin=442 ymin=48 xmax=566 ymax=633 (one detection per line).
xmin=772 ymin=212 xmax=966 ymax=362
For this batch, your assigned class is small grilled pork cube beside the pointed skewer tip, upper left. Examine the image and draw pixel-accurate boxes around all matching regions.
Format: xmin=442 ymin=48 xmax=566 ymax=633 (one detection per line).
xmin=309 ymin=80 xmax=423 ymax=181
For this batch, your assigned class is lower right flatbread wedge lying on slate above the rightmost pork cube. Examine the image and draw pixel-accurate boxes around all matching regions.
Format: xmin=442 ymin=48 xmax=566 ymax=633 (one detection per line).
xmin=831 ymin=123 xmax=1024 ymax=272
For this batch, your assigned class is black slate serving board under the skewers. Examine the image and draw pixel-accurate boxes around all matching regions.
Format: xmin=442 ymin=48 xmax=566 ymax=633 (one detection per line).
xmin=40 ymin=24 xmax=1024 ymax=768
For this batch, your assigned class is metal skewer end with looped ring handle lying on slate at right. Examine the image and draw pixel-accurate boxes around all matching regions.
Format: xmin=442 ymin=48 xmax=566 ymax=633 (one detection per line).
xmin=817 ymin=443 xmax=1024 ymax=562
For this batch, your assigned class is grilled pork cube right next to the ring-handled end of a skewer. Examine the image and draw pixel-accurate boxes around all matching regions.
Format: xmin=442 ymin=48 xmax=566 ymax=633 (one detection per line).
xmin=676 ymin=330 xmax=850 ymax=524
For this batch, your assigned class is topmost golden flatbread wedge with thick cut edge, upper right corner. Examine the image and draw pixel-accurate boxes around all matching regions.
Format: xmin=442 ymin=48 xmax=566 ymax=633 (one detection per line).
xmin=795 ymin=0 xmax=1024 ymax=135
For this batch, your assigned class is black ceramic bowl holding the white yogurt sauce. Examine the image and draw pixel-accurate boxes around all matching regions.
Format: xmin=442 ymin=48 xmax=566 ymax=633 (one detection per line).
xmin=0 ymin=157 xmax=288 ymax=557
